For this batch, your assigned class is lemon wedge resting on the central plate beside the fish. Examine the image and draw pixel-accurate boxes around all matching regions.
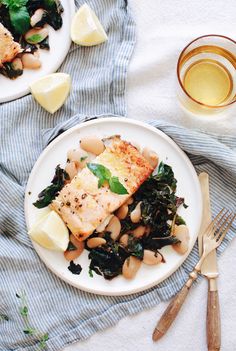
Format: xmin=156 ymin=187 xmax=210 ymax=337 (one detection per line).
xmin=29 ymin=211 xmax=69 ymax=251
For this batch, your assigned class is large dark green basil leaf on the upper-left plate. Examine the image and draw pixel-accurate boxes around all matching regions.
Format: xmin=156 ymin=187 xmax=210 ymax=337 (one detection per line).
xmin=9 ymin=6 xmax=30 ymax=34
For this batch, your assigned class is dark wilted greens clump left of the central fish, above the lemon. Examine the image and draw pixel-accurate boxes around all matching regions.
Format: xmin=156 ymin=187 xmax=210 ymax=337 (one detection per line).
xmin=33 ymin=165 xmax=70 ymax=208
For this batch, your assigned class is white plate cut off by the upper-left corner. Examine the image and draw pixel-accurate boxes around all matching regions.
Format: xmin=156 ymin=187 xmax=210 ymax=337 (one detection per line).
xmin=0 ymin=0 xmax=75 ymax=103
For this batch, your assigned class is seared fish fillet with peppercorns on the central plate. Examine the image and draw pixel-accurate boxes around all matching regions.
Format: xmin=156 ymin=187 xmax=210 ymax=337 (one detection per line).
xmin=50 ymin=139 xmax=153 ymax=240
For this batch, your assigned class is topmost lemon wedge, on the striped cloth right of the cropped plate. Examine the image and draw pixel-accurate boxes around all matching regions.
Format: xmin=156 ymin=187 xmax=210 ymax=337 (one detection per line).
xmin=71 ymin=4 xmax=107 ymax=46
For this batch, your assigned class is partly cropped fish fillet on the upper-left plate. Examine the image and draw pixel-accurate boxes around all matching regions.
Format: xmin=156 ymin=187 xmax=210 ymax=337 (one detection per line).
xmin=0 ymin=23 xmax=22 ymax=67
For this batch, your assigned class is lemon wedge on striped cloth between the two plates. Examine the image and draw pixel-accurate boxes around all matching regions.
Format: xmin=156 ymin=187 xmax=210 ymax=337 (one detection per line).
xmin=30 ymin=73 xmax=71 ymax=113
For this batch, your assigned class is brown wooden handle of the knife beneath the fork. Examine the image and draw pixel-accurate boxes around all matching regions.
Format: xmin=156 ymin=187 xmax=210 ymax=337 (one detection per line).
xmin=207 ymin=279 xmax=221 ymax=351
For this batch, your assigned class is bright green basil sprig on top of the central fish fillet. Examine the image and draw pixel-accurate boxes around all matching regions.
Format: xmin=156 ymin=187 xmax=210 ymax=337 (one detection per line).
xmin=87 ymin=163 xmax=128 ymax=195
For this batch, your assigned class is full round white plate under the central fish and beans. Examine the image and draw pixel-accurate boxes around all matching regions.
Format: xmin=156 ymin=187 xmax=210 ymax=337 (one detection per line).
xmin=25 ymin=117 xmax=202 ymax=295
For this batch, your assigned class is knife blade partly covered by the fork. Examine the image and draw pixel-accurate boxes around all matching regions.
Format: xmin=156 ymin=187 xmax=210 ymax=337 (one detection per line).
xmin=198 ymin=172 xmax=218 ymax=279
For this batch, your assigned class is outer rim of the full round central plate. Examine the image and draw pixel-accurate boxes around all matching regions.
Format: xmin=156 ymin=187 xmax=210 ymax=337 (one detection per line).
xmin=24 ymin=116 xmax=203 ymax=296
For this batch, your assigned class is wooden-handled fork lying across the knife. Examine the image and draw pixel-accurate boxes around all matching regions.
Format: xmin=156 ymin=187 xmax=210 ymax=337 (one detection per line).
xmin=152 ymin=208 xmax=236 ymax=341
